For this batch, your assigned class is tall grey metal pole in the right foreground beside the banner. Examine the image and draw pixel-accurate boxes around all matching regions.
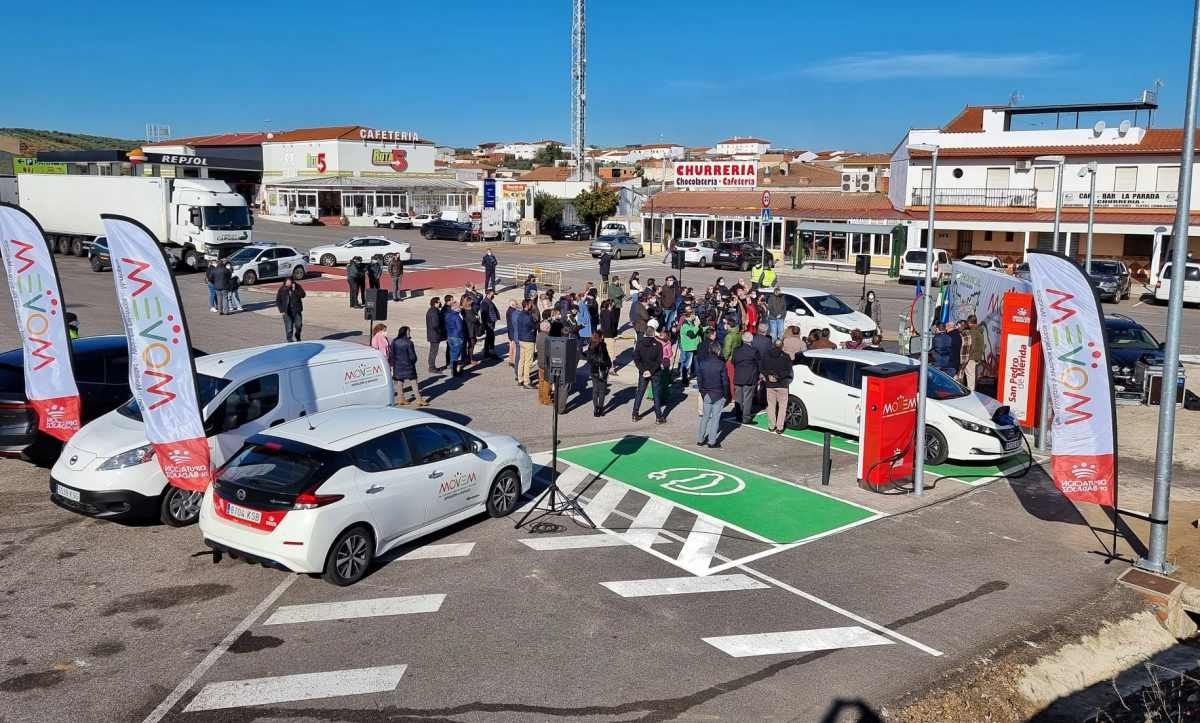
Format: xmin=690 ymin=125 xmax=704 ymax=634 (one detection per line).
xmin=1138 ymin=0 xmax=1200 ymax=574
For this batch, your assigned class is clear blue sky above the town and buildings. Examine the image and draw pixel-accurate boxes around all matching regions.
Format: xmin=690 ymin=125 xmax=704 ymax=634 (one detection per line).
xmin=0 ymin=0 xmax=1192 ymax=150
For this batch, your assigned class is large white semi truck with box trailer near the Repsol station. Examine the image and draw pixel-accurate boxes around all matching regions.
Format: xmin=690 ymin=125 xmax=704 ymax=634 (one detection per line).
xmin=17 ymin=173 xmax=253 ymax=269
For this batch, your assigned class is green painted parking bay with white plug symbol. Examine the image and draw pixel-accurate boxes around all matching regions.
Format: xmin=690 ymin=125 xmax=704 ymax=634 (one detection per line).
xmin=558 ymin=437 xmax=877 ymax=544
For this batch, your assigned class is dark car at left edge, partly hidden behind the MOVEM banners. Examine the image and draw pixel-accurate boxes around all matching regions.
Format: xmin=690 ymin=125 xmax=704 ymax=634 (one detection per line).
xmin=0 ymin=335 xmax=204 ymax=464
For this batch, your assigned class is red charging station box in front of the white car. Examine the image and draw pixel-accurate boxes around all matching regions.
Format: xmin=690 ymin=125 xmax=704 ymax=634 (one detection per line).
xmin=858 ymin=362 xmax=920 ymax=492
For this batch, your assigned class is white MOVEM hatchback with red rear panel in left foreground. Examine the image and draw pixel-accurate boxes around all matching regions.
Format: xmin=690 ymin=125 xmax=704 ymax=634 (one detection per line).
xmin=200 ymin=407 xmax=533 ymax=585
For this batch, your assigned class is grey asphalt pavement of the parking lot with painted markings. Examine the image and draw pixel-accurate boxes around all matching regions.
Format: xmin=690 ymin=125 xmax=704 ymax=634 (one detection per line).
xmin=0 ymin=228 xmax=1180 ymax=721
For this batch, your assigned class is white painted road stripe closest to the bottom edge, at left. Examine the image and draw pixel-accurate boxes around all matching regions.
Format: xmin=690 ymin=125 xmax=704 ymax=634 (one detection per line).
xmin=184 ymin=665 xmax=408 ymax=713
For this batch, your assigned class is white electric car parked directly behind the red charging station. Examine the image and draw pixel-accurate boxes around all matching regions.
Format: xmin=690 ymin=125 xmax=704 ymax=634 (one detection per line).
xmin=786 ymin=349 xmax=1022 ymax=465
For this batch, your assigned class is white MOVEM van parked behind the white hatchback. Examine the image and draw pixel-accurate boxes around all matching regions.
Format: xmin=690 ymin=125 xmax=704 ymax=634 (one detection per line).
xmin=50 ymin=341 xmax=394 ymax=527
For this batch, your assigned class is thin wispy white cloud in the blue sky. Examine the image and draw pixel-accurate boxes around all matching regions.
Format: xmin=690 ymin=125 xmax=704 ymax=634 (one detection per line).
xmin=800 ymin=52 xmax=1070 ymax=80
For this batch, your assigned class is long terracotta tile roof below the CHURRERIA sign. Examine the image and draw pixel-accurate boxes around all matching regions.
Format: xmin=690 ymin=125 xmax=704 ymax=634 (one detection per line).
xmin=642 ymin=190 xmax=905 ymax=219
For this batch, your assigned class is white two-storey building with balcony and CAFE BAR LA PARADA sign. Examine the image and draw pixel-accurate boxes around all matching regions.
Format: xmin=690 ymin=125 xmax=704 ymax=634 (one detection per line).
xmin=888 ymin=98 xmax=1200 ymax=270
